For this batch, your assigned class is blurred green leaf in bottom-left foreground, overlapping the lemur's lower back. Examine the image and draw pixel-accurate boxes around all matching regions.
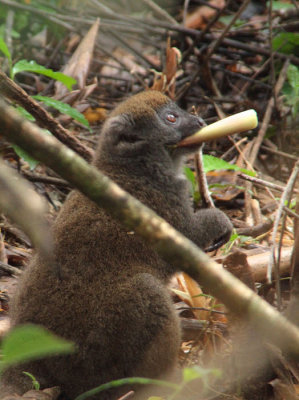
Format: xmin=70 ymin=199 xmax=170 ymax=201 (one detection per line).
xmin=1 ymin=325 xmax=74 ymax=371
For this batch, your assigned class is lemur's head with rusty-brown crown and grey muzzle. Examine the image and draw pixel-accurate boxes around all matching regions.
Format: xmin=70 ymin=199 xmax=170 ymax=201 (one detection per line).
xmin=97 ymin=91 xmax=204 ymax=170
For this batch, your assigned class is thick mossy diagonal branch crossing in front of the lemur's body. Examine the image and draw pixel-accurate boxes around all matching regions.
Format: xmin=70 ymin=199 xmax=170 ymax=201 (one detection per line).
xmin=0 ymin=101 xmax=299 ymax=360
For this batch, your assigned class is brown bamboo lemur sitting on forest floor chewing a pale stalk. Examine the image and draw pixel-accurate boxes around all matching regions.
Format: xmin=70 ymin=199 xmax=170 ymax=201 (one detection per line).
xmin=0 ymin=91 xmax=231 ymax=399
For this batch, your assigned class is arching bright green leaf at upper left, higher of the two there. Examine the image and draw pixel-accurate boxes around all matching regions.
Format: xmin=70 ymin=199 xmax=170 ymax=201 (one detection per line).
xmin=12 ymin=60 xmax=77 ymax=90
